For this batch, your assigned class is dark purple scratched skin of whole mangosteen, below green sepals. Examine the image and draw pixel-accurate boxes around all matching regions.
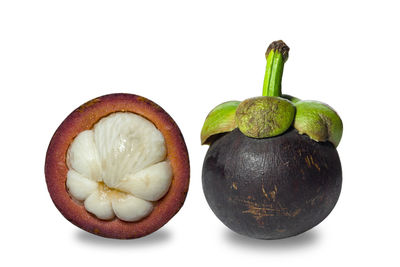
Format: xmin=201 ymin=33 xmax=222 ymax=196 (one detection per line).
xmin=203 ymin=129 xmax=342 ymax=239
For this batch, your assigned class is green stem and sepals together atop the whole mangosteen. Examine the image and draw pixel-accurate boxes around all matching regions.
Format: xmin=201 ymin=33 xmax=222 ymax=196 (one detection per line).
xmin=201 ymin=41 xmax=343 ymax=146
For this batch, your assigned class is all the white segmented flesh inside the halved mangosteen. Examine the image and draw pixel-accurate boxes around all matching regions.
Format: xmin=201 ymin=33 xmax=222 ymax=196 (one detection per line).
xmin=66 ymin=112 xmax=173 ymax=221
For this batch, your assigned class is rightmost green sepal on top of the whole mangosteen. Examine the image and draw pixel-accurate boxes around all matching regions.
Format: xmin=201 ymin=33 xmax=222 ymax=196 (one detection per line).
xmin=294 ymin=100 xmax=343 ymax=147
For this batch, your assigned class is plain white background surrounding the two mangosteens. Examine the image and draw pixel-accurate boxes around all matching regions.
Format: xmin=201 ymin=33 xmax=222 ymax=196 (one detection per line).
xmin=0 ymin=0 xmax=400 ymax=267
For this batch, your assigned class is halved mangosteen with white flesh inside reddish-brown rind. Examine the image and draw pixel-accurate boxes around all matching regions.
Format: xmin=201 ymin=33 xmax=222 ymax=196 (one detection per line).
xmin=45 ymin=94 xmax=190 ymax=239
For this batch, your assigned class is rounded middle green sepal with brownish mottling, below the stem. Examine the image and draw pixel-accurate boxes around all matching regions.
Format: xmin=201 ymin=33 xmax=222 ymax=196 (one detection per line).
xmin=236 ymin=96 xmax=296 ymax=138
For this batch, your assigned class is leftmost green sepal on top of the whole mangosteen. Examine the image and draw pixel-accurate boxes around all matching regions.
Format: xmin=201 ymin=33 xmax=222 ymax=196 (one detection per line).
xmin=201 ymin=101 xmax=240 ymax=145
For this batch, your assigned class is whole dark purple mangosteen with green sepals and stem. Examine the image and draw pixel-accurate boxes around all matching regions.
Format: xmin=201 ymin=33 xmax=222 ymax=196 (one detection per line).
xmin=201 ymin=41 xmax=343 ymax=239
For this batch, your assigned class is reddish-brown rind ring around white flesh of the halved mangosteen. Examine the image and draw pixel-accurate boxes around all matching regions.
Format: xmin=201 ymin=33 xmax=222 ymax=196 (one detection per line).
xmin=45 ymin=94 xmax=190 ymax=239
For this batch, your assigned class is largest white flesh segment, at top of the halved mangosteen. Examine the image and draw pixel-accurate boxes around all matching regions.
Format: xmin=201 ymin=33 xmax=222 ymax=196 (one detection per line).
xmin=93 ymin=112 xmax=166 ymax=187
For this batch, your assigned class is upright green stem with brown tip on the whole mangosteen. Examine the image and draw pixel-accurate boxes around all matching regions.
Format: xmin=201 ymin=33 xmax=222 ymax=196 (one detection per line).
xmin=262 ymin=41 xmax=289 ymax=96
